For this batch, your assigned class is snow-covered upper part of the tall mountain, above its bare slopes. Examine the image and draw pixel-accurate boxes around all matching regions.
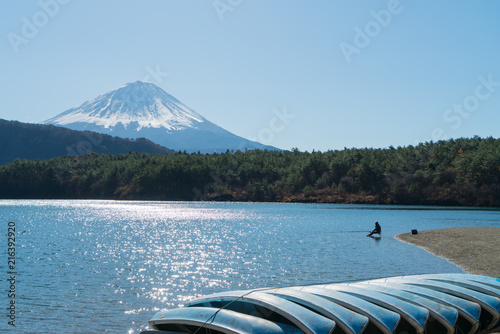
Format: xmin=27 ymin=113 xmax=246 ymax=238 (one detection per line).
xmin=44 ymin=81 xmax=206 ymax=131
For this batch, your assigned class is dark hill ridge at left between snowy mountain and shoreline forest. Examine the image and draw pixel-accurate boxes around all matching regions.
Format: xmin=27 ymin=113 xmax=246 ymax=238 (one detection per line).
xmin=0 ymin=119 xmax=174 ymax=164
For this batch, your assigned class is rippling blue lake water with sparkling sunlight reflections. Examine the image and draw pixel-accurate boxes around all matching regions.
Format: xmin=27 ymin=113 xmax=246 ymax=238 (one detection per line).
xmin=0 ymin=200 xmax=500 ymax=333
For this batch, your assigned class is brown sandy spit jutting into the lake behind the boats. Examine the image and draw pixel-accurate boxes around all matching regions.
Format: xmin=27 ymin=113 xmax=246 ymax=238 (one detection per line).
xmin=396 ymin=227 xmax=500 ymax=277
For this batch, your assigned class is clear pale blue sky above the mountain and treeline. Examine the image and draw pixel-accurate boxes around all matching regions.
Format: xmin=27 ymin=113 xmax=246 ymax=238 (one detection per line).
xmin=0 ymin=0 xmax=500 ymax=151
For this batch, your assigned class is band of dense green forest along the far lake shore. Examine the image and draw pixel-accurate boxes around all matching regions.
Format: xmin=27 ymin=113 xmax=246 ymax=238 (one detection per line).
xmin=0 ymin=137 xmax=500 ymax=207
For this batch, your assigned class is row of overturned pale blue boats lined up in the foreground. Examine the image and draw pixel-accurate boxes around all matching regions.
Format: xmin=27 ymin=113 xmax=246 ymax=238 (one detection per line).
xmin=142 ymin=274 xmax=500 ymax=334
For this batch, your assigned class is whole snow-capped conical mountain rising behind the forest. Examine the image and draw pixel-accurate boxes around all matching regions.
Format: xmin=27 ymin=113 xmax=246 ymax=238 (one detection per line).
xmin=42 ymin=81 xmax=279 ymax=153
